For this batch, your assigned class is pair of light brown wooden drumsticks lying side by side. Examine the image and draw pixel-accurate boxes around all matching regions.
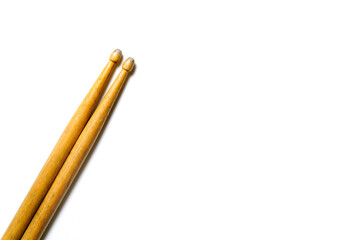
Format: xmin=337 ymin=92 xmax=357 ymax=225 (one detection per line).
xmin=1 ymin=49 xmax=134 ymax=240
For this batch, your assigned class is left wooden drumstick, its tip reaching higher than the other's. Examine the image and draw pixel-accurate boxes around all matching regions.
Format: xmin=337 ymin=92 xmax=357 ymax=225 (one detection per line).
xmin=1 ymin=49 xmax=122 ymax=240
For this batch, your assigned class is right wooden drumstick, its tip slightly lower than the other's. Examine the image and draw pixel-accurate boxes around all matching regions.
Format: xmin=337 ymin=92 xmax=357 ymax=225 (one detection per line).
xmin=21 ymin=58 xmax=134 ymax=240
